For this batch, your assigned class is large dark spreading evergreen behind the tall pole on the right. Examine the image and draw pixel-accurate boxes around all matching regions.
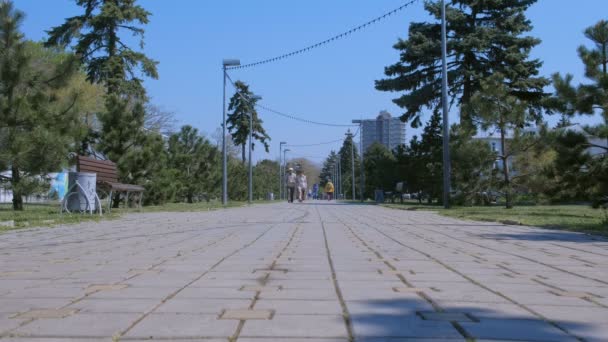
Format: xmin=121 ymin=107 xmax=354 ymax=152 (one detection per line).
xmin=376 ymin=0 xmax=548 ymax=127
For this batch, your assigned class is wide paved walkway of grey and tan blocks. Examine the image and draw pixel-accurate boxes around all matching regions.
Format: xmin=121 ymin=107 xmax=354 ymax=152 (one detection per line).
xmin=0 ymin=203 xmax=608 ymax=342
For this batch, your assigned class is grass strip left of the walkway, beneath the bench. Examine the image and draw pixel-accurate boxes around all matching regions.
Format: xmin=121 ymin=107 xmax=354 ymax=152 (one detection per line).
xmin=0 ymin=201 xmax=268 ymax=233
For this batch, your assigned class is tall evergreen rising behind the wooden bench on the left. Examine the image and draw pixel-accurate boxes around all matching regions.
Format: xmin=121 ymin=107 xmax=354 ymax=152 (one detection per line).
xmin=46 ymin=0 xmax=158 ymax=198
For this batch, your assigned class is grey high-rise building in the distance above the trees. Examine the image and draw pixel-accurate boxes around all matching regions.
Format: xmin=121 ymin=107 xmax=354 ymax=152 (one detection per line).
xmin=354 ymin=110 xmax=405 ymax=152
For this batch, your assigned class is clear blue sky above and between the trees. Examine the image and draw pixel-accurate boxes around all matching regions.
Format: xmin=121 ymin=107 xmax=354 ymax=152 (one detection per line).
xmin=15 ymin=0 xmax=608 ymax=165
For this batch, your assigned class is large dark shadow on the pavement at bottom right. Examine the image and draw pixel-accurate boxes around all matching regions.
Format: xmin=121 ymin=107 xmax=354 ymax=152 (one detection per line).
xmin=347 ymin=297 xmax=602 ymax=341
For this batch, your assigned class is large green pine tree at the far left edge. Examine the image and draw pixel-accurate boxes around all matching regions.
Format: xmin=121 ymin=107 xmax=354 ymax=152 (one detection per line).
xmin=0 ymin=1 xmax=88 ymax=210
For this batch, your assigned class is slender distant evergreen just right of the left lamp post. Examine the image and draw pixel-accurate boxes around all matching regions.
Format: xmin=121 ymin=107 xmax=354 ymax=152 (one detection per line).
xmin=226 ymin=81 xmax=270 ymax=163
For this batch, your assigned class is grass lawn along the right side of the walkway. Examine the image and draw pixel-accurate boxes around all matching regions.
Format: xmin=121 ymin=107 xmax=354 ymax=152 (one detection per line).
xmin=383 ymin=202 xmax=608 ymax=236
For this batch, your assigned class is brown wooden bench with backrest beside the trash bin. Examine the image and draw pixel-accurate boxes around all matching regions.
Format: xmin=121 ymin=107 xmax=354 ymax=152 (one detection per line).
xmin=76 ymin=156 xmax=145 ymax=211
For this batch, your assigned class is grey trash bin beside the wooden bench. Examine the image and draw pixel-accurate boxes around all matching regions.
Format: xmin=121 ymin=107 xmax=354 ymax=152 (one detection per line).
xmin=66 ymin=172 xmax=97 ymax=212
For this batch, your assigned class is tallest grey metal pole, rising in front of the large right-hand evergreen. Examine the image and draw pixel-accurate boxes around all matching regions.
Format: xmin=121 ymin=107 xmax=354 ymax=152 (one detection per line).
xmin=441 ymin=0 xmax=451 ymax=209
